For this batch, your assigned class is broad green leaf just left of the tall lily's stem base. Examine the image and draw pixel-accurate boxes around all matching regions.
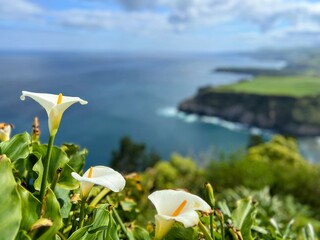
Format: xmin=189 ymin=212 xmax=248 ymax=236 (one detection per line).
xmin=18 ymin=186 xmax=41 ymax=231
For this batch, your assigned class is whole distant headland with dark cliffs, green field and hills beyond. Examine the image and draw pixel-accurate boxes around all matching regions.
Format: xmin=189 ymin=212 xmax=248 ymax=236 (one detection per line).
xmin=178 ymin=49 xmax=320 ymax=136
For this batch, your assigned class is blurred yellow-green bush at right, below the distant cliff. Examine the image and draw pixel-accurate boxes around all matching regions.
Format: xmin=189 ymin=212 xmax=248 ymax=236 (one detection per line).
xmin=206 ymin=136 xmax=320 ymax=217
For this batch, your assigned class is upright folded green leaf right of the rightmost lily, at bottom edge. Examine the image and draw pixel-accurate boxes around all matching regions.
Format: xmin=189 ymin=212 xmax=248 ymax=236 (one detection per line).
xmin=232 ymin=198 xmax=256 ymax=240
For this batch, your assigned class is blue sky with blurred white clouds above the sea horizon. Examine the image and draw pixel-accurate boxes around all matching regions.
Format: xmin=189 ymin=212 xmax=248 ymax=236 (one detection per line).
xmin=0 ymin=0 xmax=320 ymax=52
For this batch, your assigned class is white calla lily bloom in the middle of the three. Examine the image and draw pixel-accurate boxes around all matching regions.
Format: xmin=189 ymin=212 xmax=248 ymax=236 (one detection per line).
xmin=71 ymin=166 xmax=126 ymax=197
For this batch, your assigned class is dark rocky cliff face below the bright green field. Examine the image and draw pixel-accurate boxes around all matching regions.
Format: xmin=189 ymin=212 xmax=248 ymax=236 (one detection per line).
xmin=179 ymin=88 xmax=320 ymax=136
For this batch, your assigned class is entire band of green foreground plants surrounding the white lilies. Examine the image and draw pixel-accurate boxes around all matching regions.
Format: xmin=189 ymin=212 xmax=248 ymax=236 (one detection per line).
xmin=0 ymin=128 xmax=320 ymax=240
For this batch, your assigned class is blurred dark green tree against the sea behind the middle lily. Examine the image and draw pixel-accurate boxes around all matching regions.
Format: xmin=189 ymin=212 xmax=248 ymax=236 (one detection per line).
xmin=111 ymin=137 xmax=160 ymax=173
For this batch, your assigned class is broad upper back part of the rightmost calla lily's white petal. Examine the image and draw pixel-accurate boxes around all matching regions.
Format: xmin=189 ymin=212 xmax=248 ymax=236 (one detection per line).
xmin=148 ymin=190 xmax=211 ymax=216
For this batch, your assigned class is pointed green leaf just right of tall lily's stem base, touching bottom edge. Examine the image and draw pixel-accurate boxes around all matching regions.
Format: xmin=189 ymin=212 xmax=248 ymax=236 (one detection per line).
xmin=38 ymin=188 xmax=63 ymax=240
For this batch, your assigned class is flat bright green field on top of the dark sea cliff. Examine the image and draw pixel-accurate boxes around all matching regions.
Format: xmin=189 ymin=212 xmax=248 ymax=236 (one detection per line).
xmin=212 ymin=76 xmax=320 ymax=97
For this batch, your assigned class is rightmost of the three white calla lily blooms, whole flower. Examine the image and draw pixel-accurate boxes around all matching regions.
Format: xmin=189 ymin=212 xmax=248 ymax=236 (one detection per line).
xmin=148 ymin=190 xmax=211 ymax=239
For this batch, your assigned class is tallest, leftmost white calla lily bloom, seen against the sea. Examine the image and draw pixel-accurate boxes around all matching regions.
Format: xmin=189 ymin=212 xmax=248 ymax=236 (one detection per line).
xmin=20 ymin=91 xmax=88 ymax=136
